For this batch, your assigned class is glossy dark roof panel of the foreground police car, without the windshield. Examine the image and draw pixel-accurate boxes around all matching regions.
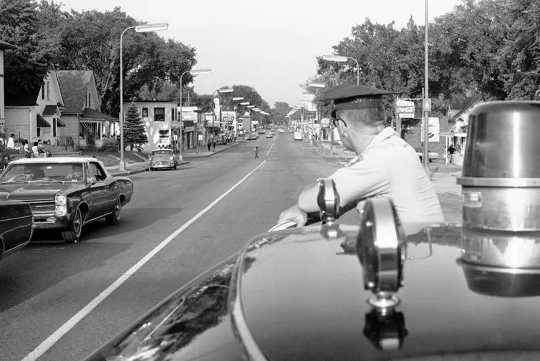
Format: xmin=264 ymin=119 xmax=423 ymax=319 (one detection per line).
xmin=238 ymin=227 xmax=540 ymax=360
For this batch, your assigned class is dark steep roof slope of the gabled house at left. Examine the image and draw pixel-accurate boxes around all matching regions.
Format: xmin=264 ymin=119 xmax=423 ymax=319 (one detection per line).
xmin=56 ymin=70 xmax=97 ymax=113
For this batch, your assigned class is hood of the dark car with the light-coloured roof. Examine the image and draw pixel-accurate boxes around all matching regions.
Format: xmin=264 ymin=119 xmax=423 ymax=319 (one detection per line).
xmin=0 ymin=182 xmax=82 ymax=201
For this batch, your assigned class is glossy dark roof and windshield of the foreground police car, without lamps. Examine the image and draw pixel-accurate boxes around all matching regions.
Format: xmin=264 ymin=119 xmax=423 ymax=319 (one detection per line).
xmin=88 ymin=225 xmax=540 ymax=361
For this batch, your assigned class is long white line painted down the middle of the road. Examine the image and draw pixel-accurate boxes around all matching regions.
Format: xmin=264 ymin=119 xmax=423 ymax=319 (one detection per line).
xmin=22 ymin=160 xmax=266 ymax=361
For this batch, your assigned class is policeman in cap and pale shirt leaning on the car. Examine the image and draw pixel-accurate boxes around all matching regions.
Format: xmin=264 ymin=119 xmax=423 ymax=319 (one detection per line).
xmin=279 ymin=85 xmax=443 ymax=226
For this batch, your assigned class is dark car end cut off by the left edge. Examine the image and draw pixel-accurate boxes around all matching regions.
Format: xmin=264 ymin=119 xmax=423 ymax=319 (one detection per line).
xmin=0 ymin=201 xmax=33 ymax=257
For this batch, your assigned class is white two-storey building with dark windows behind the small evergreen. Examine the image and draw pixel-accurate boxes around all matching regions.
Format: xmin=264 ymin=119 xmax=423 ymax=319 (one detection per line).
xmin=124 ymin=100 xmax=180 ymax=152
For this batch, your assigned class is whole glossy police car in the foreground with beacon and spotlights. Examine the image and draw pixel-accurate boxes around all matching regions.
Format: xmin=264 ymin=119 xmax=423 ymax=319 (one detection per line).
xmin=84 ymin=102 xmax=540 ymax=361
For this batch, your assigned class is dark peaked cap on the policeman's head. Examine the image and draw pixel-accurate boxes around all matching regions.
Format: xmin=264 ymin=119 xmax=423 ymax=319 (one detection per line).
xmin=318 ymin=84 xmax=394 ymax=110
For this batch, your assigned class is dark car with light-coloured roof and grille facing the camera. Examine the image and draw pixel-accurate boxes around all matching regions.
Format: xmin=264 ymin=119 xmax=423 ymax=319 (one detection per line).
xmin=0 ymin=157 xmax=133 ymax=242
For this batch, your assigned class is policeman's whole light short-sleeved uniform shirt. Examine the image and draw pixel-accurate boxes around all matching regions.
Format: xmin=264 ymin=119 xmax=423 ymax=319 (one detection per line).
xmin=331 ymin=127 xmax=444 ymax=223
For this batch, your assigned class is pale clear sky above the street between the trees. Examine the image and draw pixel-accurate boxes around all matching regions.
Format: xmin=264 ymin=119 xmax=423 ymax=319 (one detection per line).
xmin=60 ymin=0 xmax=461 ymax=106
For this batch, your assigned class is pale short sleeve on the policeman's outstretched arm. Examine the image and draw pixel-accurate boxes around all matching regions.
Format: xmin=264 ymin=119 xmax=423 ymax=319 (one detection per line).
xmin=330 ymin=159 xmax=390 ymax=207
